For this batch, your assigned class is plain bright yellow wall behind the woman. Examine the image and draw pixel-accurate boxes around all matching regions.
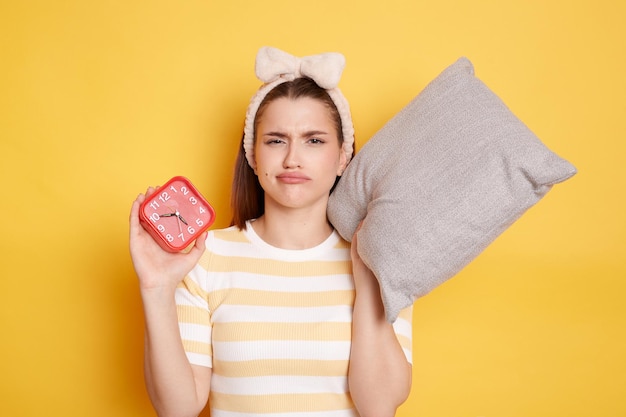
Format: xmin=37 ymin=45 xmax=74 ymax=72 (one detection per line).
xmin=0 ymin=0 xmax=626 ymax=417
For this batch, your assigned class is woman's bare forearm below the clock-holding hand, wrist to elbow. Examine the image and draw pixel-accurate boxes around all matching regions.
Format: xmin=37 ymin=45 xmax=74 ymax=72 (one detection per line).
xmin=142 ymin=289 xmax=208 ymax=417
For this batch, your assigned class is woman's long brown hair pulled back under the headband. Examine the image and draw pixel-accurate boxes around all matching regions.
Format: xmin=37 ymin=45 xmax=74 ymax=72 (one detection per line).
xmin=231 ymin=78 xmax=343 ymax=229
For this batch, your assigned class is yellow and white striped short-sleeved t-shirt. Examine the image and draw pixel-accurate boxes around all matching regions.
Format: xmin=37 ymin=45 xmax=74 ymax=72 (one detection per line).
xmin=176 ymin=219 xmax=412 ymax=417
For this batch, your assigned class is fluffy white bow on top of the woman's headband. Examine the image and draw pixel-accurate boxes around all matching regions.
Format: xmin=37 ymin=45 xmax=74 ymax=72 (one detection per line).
xmin=255 ymin=46 xmax=346 ymax=90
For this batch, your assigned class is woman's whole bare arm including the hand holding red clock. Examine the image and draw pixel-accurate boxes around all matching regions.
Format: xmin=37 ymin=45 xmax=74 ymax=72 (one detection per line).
xmin=130 ymin=188 xmax=211 ymax=417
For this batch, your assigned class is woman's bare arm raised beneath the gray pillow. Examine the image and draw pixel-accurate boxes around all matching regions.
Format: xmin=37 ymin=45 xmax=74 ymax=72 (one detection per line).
xmin=348 ymin=234 xmax=412 ymax=417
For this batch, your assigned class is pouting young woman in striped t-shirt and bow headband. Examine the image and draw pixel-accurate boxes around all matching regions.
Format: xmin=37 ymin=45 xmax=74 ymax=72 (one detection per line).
xmin=130 ymin=48 xmax=411 ymax=417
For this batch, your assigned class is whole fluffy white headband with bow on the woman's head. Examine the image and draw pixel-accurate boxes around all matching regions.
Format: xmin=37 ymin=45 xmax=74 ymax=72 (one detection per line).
xmin=243 ymin=46 xmax=354 ymax=168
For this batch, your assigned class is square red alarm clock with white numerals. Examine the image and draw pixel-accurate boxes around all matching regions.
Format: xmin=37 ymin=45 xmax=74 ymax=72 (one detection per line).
xmin=139 ymin=176 xmax=215 ymax=252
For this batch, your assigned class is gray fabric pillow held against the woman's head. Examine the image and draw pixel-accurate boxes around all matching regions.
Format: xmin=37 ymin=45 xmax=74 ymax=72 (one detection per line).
xmin=328 ymin=58 xmax=576 ymax=322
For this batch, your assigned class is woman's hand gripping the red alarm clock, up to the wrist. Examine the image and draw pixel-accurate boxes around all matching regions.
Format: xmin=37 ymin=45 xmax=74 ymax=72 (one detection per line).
xmin=130 ymin=187 xmax=207 ymax=291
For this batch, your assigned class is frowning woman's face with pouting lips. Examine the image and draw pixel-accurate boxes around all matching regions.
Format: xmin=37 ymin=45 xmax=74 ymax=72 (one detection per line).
xmin=254 ymin=98 xmax=346 ymax=211
